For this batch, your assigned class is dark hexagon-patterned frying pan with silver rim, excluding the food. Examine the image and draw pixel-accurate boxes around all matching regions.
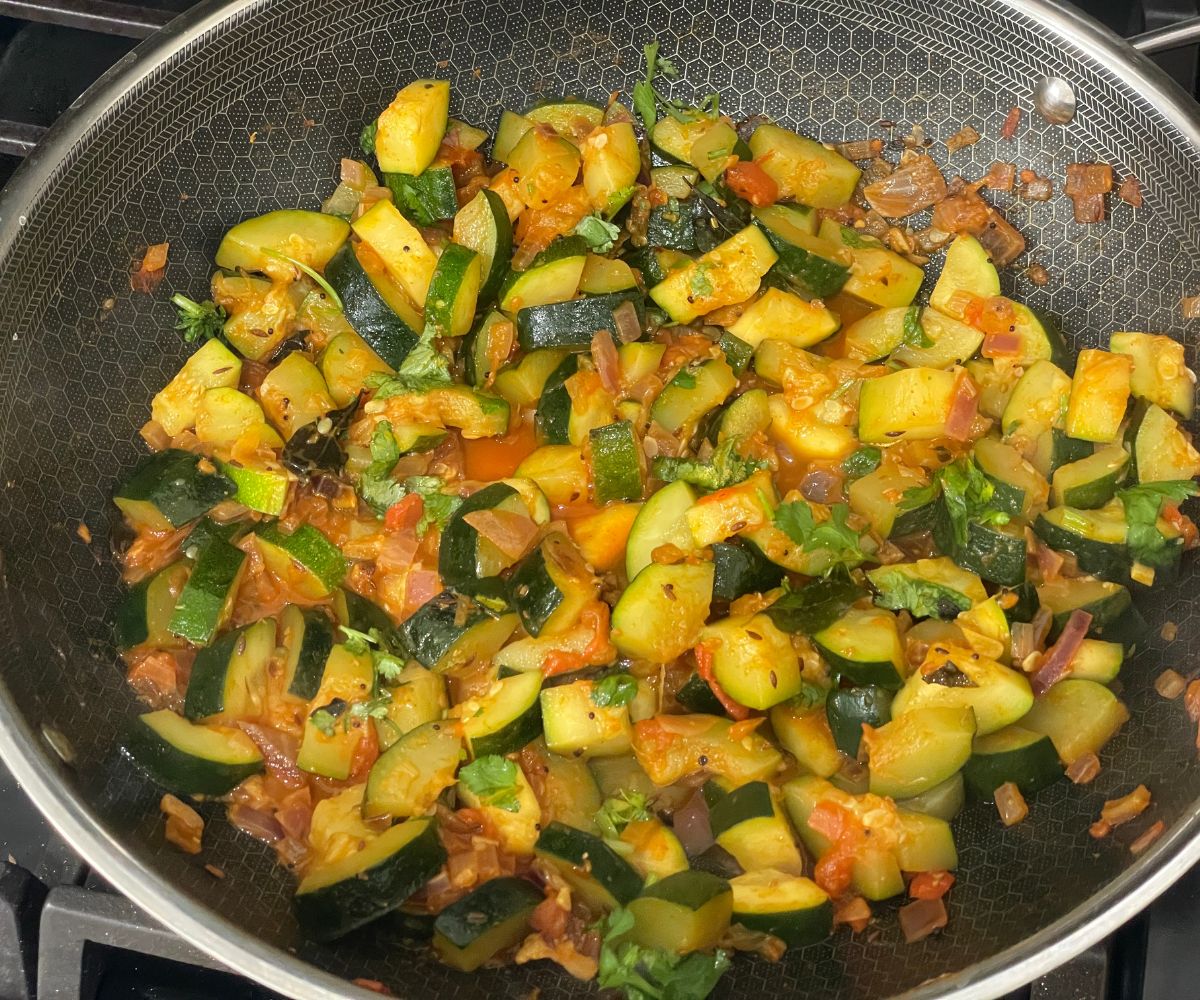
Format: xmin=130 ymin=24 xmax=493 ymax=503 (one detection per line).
xmin=0 ymin=0 xmax=1200 ymax=1000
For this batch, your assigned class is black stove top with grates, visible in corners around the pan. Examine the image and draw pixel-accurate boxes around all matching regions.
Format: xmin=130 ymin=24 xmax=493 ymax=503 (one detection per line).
xmin=0 ymin=0 xmax=1200 ymax=1000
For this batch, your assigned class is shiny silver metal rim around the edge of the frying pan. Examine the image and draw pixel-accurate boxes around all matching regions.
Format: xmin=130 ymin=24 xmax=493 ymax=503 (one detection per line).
xmin=0 ymin=0 xmax=1200 ymax=1000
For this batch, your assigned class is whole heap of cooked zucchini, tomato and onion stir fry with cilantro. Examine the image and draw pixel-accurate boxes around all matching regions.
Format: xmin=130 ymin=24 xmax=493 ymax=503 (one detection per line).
xmin=115 ymin=62 xmax=1200 ymax=1000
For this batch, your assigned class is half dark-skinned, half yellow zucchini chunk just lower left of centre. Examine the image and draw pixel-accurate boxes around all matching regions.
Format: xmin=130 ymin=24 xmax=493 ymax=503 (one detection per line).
xmin=400 ymin=591 xmax=520 ymax=673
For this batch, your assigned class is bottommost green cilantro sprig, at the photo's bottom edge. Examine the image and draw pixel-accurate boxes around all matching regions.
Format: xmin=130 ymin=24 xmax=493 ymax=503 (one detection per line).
xmin=596 ymin=908 xmax=730 ymax=1000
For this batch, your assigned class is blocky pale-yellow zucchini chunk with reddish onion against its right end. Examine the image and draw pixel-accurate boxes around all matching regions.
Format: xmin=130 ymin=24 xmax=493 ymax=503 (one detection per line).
xmin=858 ymin=369 xmax=958 ymax=444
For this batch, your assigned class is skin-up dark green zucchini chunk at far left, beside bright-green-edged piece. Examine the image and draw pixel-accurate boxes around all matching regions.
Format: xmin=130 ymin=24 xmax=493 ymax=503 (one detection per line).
xmin=113 ymin=448 xmax=238 ymax=532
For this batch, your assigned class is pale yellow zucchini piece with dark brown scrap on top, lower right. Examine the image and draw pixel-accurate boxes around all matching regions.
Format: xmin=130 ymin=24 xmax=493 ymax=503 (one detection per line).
xmin=892 ymin=642 xmax=1033 ymax=736
